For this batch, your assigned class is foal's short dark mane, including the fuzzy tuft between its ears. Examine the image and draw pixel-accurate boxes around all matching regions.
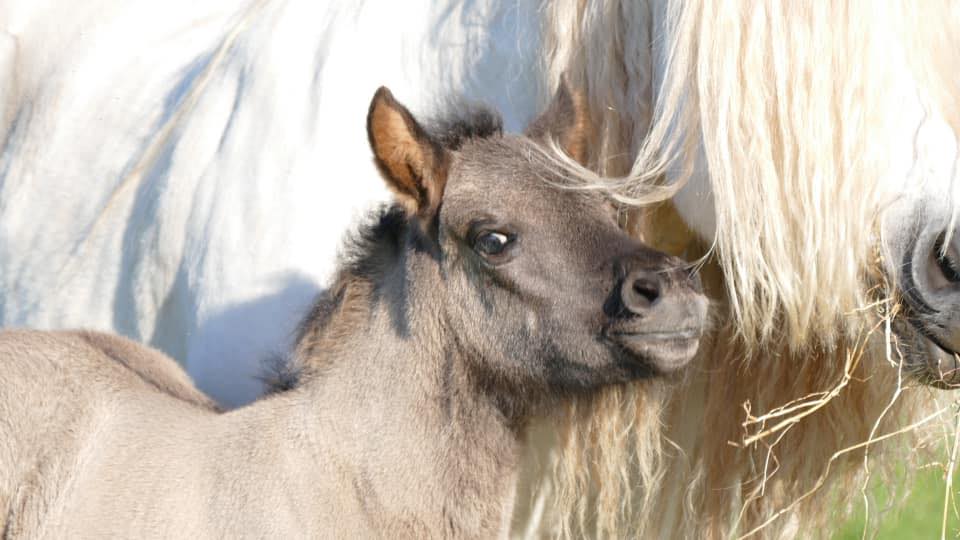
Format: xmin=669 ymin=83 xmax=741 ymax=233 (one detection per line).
xmin=263 ymin=102 xmax=503 ymax=393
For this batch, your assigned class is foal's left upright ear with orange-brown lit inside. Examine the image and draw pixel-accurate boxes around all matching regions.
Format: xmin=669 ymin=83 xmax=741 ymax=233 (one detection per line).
xmin=367 ymin=86 xmax=449 ymax=220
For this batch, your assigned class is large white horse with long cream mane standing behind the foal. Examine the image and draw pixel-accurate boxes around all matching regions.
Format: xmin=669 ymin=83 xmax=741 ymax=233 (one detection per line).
xmin=0 ymin=0 xmax=960 ymax=535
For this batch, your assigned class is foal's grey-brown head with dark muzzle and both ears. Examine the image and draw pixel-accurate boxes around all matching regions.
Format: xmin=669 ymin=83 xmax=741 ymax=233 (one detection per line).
xmin=367 ymin=84 xmax=706 ymax=400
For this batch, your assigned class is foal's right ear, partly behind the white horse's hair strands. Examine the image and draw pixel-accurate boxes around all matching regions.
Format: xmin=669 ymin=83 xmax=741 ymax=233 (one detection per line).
xmin=524 ymin=76 xmax=590 ymax=165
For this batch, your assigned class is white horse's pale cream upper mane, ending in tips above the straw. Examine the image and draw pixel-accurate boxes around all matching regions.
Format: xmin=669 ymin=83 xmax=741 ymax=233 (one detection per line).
xmin=545 ymin=1 xmax=960 ymax=347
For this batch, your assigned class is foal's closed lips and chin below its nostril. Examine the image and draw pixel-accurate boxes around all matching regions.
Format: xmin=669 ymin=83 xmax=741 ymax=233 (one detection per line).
xmin=607 ymin=328 xmax=703 ymax=373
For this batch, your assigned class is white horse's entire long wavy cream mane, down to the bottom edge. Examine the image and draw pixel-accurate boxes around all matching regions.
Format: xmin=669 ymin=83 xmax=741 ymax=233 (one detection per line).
xmin=521 ymin=0 xmax=960 ymax=538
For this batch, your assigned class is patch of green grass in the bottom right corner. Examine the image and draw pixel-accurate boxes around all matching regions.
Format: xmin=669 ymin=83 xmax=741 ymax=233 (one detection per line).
xmin=834 ymin=469 xmax=960 ymax=540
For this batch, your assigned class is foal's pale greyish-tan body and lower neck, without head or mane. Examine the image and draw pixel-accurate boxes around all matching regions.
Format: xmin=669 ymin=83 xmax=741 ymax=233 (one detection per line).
xmin=0 ymin=331 xmax=517 ymax=538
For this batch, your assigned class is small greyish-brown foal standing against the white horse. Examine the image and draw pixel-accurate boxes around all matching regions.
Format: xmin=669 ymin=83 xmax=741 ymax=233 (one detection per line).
xmin=0 ymin=85 xmax=706 ymax=538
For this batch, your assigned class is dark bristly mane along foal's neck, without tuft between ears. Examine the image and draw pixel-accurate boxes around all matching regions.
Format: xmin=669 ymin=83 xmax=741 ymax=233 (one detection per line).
xmin=262 ymin=204 xmax=410 ymax=393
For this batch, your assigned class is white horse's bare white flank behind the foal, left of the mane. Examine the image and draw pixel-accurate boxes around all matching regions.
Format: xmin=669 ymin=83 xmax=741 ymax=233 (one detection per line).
xmin=0 ymin=0 xmax=539 ymax=405
